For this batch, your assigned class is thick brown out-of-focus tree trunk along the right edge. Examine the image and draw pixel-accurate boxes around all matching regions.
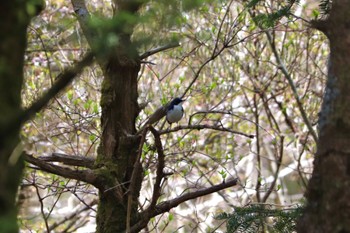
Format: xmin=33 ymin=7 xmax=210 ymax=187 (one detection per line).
xmin=298 ymin=0 xmax=350 ymax=233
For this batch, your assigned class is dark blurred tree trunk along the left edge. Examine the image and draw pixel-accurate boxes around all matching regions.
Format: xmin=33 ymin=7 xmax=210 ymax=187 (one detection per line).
xmin=0 ymin=0 xmax=40 ymax=233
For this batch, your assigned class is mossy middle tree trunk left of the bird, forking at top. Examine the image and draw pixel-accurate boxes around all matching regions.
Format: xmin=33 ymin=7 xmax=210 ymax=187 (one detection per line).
xmin=72 ymin=0 xmax=142 ymax=233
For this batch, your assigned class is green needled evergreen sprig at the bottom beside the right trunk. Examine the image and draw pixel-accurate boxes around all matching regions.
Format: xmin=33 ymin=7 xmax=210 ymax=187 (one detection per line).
xmin=216 ymin=204 xmax=304 ymax=233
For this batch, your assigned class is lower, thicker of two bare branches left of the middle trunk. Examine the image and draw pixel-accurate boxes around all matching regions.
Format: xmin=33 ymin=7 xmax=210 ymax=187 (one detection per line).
xmin=24 ymin=154 xmax=103 ymax=188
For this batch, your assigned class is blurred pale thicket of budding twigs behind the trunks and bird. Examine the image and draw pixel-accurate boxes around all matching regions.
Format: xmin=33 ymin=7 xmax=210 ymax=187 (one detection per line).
xmin=14 ymin=0 xmax=328 ymax=232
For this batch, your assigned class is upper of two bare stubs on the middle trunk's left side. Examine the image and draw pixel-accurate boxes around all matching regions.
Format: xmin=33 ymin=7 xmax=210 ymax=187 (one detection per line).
xmin=38 ymin=153 xmax=95 ymax=169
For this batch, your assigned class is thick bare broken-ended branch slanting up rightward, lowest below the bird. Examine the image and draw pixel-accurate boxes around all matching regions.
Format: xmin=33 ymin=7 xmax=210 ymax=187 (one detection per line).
xmin=131 ymin=179 xmax=237 ymax=233
